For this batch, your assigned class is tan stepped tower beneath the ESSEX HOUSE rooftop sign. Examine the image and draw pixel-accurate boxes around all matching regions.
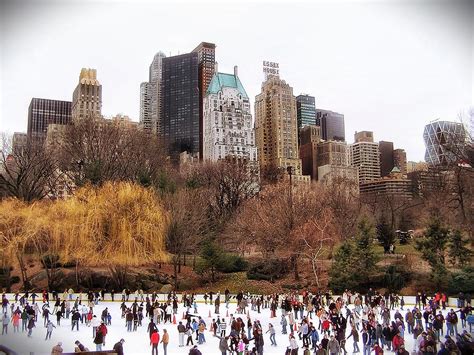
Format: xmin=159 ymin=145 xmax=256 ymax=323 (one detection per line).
xmin=255 ymin=75 xmax=301 ymax=175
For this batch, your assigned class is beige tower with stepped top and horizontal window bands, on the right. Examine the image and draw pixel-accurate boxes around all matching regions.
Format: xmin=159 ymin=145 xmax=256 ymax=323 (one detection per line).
xmin=350 ymin=131 xmax=380 ymax=184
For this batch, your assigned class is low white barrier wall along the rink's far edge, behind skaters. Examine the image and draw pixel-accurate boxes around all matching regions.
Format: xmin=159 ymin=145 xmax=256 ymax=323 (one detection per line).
xmin=1 ymin=293 xmax=462 ymax=307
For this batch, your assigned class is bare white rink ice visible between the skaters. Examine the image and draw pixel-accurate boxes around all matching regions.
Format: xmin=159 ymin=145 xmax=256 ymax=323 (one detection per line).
xmin=0 ymin=298 xmax=470 ymax=355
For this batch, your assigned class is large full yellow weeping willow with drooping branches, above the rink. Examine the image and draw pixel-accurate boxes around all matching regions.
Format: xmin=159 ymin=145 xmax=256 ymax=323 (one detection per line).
xmin=72 ymin=182 xmax=169 ymax=288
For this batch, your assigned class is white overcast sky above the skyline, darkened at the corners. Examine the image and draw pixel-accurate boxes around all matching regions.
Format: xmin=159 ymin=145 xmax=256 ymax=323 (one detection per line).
xmin=0 ymin=0 xmax=474 ymax=160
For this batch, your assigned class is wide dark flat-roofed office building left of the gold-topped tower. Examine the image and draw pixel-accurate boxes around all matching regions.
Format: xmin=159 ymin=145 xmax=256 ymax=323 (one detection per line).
xmin=27 ymin=98 xmax=71 ymax=141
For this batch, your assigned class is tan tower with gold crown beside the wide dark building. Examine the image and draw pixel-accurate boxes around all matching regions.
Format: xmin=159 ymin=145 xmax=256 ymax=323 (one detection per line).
xmin=72 ymin=68 xmax=102 ymax=120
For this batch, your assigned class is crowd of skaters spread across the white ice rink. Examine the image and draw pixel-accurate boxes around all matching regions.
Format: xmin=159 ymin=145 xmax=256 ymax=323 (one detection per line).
xmin=2 ymin=289 xmax=474 ymax=355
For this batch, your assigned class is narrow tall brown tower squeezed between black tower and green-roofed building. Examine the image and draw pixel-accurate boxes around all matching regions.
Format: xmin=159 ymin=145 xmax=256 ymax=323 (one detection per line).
xmin=193 ymin=42 xmax=216 ymax=159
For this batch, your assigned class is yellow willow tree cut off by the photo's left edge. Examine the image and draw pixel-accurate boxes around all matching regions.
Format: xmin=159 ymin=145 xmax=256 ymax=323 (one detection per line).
xmin=0 ymin=198 xmax=32 ymax=290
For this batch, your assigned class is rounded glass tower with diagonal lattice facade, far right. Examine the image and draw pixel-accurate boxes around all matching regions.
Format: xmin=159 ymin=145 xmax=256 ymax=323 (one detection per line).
xmin=423 ymin=121 xmax=466 ymax=165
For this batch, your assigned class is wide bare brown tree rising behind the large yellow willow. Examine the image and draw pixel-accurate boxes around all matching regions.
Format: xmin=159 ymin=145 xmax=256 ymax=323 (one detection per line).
xmin=51 ymin=117 xmax=166 ymax=186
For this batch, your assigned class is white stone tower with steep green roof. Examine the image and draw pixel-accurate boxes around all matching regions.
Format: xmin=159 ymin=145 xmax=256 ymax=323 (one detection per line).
xmin=203 ymin=67 xmax=258 ymax=166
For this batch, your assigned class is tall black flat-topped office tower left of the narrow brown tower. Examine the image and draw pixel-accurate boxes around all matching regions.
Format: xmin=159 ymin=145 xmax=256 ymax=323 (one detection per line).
xmin=160 ymin=52 xmax=202 ymax=159
